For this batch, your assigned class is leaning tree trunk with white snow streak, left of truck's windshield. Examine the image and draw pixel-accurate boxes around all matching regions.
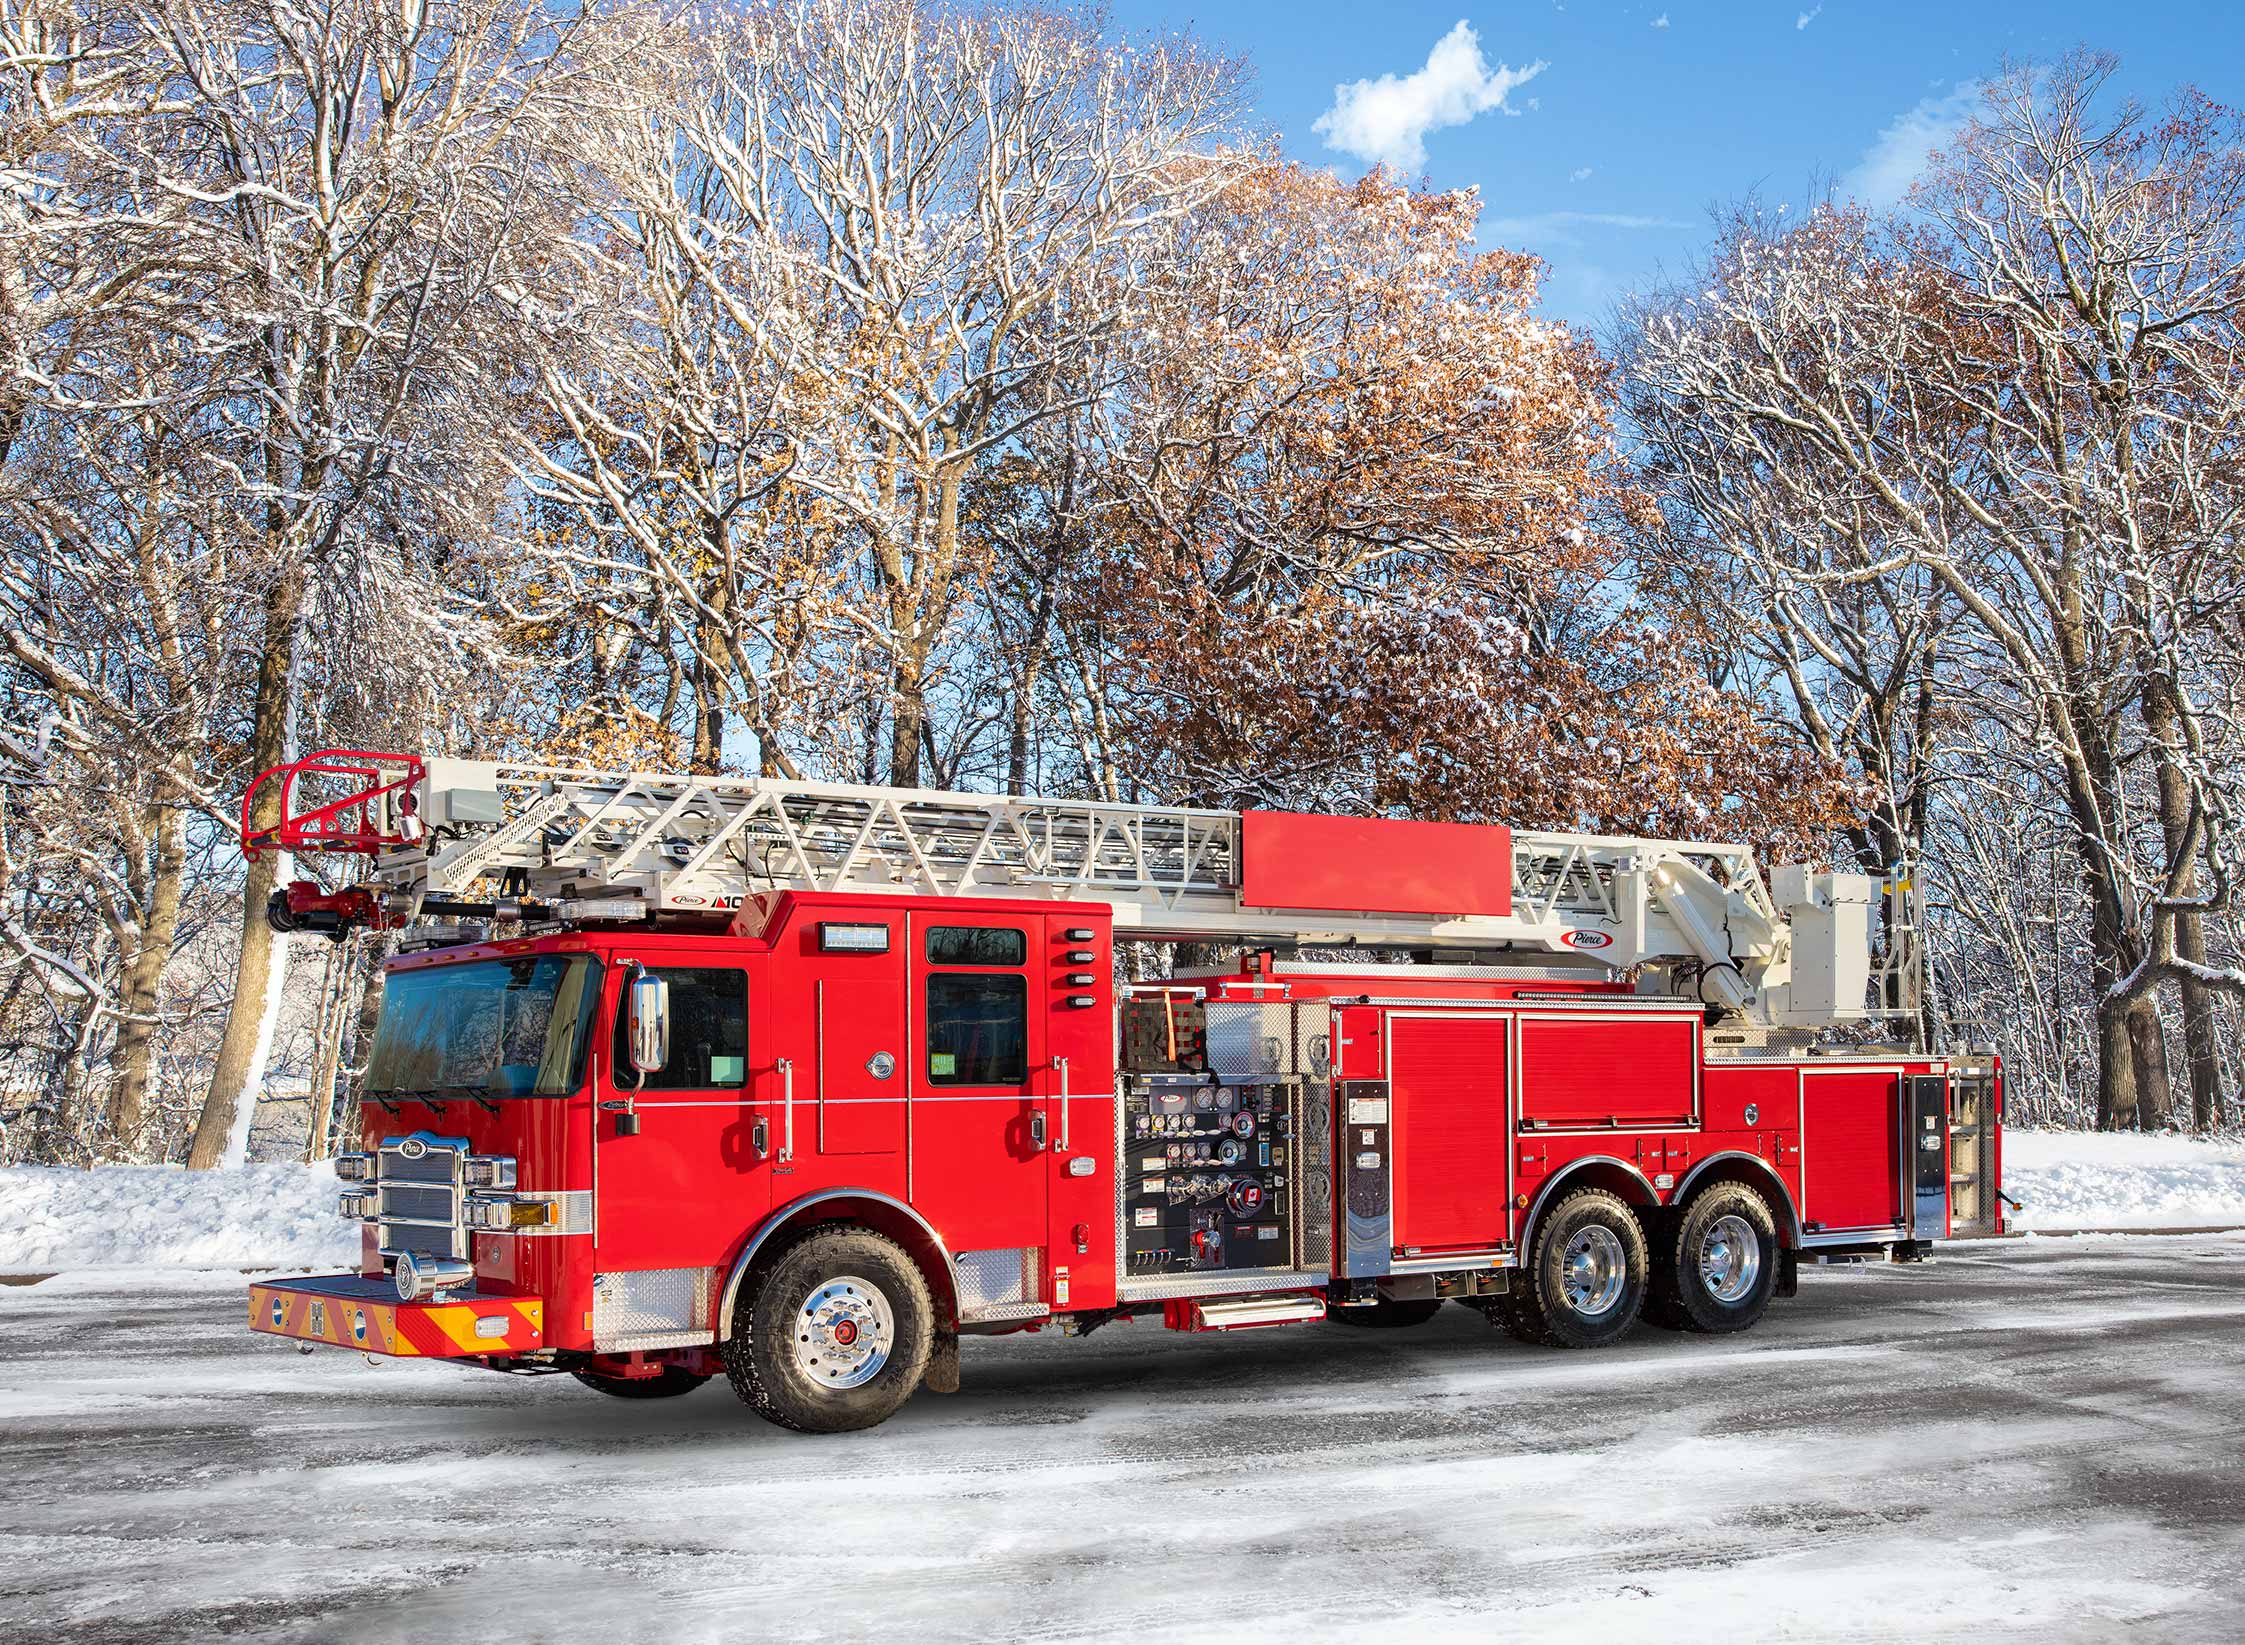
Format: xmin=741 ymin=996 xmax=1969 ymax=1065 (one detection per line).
xmin=186 ymin=566 xmax=305 ymax=1171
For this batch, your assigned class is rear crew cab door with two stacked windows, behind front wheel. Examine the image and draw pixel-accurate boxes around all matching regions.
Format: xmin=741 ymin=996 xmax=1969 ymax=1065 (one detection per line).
xmin=905 ymin=909 xmax=1051 ymax=1256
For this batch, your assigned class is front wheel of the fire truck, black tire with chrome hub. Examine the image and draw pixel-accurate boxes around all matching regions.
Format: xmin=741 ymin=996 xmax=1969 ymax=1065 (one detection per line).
xmin=723 ymin=1223 xmax=936 ymax=1434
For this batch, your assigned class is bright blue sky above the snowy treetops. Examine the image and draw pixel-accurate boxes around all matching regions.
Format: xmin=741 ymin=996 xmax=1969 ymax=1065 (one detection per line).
xmin=1114 ymin=0 xmax=2245 ymax=334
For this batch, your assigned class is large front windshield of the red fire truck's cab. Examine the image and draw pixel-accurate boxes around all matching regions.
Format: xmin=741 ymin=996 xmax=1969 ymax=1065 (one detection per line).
xmin=366 ymin=954 xmax=599 ymax=1097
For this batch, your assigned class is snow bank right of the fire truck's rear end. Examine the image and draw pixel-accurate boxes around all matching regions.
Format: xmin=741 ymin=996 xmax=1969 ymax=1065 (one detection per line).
xmin=2003 ymin=1131 xmax=2245 ymax=1228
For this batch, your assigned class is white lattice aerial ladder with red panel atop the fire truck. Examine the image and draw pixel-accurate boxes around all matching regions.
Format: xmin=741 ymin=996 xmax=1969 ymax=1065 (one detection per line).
xmin=245 ymin=752 xmax=1917 ymax=1026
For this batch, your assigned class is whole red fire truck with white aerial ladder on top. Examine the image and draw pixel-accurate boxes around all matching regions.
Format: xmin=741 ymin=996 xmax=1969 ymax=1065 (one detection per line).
xmin=245 ymin=752 xmax=2003 ymax=1432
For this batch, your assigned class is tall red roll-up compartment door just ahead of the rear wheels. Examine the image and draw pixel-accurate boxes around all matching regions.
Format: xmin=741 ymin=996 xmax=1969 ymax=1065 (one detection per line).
xmin=1387 ymin=1012 xmax=1511 ymax=1252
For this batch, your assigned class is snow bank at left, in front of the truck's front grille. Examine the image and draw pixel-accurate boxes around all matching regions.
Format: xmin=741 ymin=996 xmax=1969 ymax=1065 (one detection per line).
xmin=0 ymin=1165 xmax=359 ymax=1275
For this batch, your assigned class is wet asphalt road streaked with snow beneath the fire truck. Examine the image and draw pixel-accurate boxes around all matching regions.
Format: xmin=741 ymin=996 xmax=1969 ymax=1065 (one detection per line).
xmin=0 ymin=1234 xmax=2245 ymax=1641
